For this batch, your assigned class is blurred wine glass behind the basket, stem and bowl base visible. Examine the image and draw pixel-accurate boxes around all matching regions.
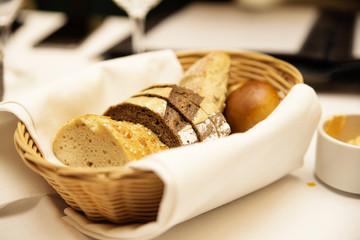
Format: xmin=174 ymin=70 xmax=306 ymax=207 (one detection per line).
xmin=113 ymin=0 xmax=161 ymax=53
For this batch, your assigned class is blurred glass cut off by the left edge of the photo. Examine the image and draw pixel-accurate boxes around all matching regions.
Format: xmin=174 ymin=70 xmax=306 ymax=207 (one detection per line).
xmin=0 ymin=0 xmax=23 ymax=101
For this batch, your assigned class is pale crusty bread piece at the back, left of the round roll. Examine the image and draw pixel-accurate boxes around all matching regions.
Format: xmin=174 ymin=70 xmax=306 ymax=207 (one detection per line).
xmin=179 ymin=51 xmax=231 ymax=112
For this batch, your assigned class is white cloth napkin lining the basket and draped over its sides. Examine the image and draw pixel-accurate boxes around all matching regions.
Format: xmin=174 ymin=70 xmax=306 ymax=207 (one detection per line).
xmin=0 ymin=50 xmax=321 ymax=239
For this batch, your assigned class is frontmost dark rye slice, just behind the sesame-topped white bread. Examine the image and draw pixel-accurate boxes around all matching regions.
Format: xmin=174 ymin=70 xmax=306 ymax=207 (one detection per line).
xmin=103 ymin=96 xmax=199 ymax=148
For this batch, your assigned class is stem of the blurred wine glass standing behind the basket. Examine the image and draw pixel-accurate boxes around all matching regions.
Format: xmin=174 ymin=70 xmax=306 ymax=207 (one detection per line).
xmin=130 ymin=16 xmax=145 ymax=53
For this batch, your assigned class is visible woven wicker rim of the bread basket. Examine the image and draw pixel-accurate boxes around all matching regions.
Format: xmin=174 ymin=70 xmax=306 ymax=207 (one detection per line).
xmin=14 ymin=49 xmax=303 ymax=181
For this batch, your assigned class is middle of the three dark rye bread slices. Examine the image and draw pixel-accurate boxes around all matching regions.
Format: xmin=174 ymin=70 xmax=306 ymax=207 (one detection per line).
xmin=135 ymin=85 xmax=219 ymax=141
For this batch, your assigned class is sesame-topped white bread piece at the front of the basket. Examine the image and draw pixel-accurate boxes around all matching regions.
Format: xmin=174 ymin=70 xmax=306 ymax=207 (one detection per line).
xmin=53 ymin=114 xmax=168 ymax=168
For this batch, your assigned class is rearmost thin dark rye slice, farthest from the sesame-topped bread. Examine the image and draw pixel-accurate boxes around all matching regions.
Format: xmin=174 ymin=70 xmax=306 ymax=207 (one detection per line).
xmin=143 ymin=84 xmax=231 ymax=137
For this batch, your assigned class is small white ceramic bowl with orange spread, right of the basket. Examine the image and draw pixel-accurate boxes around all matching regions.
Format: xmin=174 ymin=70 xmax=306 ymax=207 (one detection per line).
xmin=315 ymin=115 xmax=360 ymax=194
